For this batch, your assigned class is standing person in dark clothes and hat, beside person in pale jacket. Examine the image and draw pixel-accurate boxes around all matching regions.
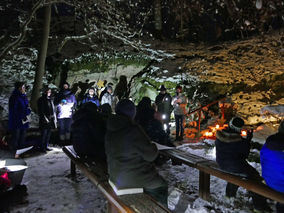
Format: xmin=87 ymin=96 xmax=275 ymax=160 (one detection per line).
xmin=155 ymin=85 xmax=172 ymax=135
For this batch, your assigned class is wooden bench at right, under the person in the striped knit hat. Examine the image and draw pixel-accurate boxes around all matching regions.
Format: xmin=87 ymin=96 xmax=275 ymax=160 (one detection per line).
xmin=160 ymin=149 xmax=284 ymax=203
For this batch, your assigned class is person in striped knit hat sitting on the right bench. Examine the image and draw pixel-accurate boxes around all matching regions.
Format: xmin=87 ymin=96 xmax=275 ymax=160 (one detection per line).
xmin=215 ymin=117 xmax=268 ymax=211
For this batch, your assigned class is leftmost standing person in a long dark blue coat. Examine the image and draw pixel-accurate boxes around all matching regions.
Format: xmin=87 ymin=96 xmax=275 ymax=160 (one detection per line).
xmin=9 ymin=82 xmax=31 ymax=158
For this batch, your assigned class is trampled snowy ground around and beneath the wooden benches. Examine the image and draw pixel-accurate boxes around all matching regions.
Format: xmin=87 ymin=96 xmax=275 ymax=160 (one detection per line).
xmin=11 ymin=141 xmax=274 ymax=213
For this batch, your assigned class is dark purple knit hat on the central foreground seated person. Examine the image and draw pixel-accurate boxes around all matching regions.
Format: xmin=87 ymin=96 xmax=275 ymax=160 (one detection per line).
xmin=115 ymin=99 xmax=136 ymax=119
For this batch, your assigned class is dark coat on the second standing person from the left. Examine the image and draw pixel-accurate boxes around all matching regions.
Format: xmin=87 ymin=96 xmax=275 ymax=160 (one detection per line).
xmin=37 ymin=94 xmax=57 ymax=129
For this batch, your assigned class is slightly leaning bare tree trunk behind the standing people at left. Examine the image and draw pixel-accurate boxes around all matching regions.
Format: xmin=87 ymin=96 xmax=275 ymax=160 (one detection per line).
xmin=31 ymin=5 xmax=51 ymax=112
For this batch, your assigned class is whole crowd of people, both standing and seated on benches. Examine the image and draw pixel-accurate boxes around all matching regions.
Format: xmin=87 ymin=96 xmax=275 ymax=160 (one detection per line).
xmin=3 ymin=77 xmax=284 ymax=213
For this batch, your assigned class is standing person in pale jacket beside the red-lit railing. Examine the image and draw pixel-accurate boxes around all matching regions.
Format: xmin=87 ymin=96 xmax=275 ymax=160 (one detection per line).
xmin=172 ymin=85 xmax=187 ymax=141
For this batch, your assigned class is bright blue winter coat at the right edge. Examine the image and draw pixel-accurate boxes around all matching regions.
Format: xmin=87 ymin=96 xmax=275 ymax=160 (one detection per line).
xmin=260 ymin=133 xmax=284 ymax=193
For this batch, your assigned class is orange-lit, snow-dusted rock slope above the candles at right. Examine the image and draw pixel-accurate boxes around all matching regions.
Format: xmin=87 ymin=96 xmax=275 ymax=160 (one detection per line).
xmin=149 ymin=33 xmax=284 ymax=124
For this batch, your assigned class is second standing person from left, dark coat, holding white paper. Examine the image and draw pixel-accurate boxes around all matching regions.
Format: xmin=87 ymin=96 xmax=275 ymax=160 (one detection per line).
xmin=37 ymin=88 xmax=57 ymax=152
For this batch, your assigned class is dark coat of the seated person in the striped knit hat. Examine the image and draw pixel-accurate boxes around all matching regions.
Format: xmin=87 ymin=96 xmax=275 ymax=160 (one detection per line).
xmin=215 ymin=128 xmax=250 ymax=174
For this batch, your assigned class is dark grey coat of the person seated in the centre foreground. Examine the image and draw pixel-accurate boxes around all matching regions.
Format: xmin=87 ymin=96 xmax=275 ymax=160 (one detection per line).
xmin=105 ymin=115 xmax=166 ymax=189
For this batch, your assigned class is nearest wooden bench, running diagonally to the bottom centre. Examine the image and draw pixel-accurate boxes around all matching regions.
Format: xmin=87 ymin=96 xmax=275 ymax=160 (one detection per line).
xmin=63 ymin=146 xmax=170 ymax=213
